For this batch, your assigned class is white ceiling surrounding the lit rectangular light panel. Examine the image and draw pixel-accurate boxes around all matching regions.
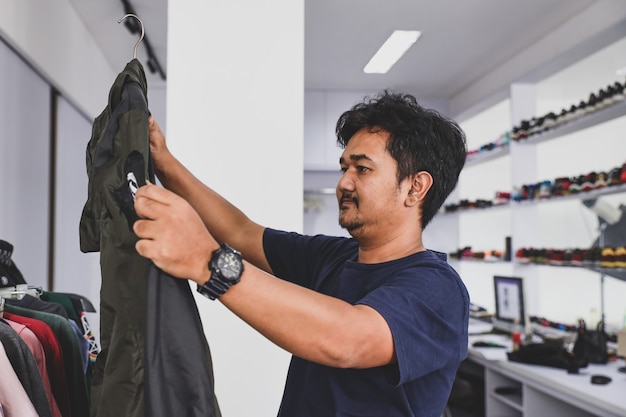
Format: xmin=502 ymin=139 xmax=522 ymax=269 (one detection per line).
xmin=70 ymin=0 xmax=626 ymax=114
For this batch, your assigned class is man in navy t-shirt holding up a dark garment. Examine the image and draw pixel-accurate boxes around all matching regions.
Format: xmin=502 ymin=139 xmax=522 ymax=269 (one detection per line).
xmin=134 ymin=91 xmax=469 ymax=417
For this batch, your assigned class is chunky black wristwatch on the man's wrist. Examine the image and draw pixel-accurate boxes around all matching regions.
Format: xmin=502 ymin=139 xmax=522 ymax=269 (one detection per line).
xmin=198 ymin=243 xmax=243 ymax=300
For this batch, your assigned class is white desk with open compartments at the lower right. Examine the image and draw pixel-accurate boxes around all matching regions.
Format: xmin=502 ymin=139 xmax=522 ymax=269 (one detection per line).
xmin=468 ymin=335 xmax=626 ymax=417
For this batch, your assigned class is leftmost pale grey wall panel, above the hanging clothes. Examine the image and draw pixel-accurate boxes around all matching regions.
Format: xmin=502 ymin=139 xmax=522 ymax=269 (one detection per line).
xmin=0 ymin=42 xmax=50 ymax=286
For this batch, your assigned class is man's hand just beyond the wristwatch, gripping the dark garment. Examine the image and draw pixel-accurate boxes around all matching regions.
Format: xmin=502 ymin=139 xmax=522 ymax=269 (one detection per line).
xmin=133 ymin=184 xmax=218 ymax=284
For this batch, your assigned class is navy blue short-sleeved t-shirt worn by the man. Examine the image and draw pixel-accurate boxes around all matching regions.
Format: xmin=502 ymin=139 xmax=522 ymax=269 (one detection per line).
xmin=263 ymin=229 xmax=469 ymax=417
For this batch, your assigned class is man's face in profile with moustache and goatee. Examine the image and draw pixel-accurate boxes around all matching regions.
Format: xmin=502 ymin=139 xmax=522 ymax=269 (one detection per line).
xmin=336 ymin=129 xmax=408 ymax=237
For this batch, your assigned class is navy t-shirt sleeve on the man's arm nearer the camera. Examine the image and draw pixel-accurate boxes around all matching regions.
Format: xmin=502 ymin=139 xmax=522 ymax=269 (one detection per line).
xmin=358 ymin=266 xmax=469 ymax=385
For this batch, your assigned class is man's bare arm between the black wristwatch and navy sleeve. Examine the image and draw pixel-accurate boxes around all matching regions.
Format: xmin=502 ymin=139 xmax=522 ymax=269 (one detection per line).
xmin=214 ymin=265 xmax=395 ymax=368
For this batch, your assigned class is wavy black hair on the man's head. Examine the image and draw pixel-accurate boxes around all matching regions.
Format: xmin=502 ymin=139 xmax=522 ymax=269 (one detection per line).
xmin=335 ymin=90 xmax=467 ymax=230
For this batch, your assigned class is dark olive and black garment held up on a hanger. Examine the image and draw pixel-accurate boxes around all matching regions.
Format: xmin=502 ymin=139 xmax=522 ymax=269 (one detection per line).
xmin=80 ymin=59 xmax=221 ymax=417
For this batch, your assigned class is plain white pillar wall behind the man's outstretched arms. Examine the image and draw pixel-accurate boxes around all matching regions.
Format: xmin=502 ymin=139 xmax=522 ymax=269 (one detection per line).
xmin=167 ymin=0 xmax=304 ymax=416
